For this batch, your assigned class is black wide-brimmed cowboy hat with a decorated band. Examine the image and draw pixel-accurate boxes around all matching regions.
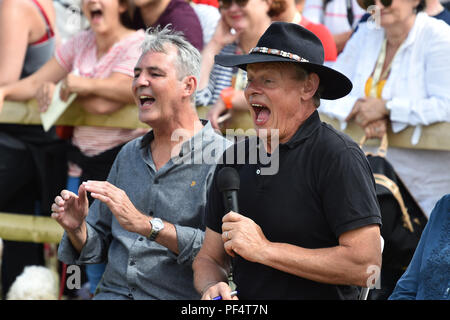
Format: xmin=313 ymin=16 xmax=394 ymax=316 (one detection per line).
xmin=215 ymin=22 xmax=353 ymax=100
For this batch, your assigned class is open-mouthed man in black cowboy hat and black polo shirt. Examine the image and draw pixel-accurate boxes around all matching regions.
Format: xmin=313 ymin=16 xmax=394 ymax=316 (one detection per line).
xmin=193 ymin=22 xmax=381 ymax=299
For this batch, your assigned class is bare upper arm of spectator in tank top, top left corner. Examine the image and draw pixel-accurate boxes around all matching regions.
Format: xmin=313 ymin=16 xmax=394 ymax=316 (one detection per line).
xmin=0 ymin=0 xmax=31 ymax=86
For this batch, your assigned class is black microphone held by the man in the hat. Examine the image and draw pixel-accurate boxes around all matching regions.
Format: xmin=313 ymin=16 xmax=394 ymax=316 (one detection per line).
xmin=217 ymin=167 xmax=240 ymax=213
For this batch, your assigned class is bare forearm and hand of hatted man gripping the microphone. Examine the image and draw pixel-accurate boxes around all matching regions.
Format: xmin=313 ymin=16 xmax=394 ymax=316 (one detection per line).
xmin=222 ymin=212 xmax=381 ymax=287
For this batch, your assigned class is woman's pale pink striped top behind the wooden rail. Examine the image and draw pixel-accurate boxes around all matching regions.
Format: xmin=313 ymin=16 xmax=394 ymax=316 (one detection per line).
xmin=55 ymin=30 xmax=148 ymax=160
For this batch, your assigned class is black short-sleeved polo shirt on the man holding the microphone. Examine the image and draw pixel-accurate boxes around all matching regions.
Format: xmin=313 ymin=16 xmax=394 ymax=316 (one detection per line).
xmin=206 ymin=111 xmax=381 ymax=299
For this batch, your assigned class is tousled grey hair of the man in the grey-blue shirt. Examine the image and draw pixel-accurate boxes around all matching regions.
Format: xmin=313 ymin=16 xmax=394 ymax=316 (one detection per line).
xmin=141 ymin=24 xmax=201 ymax=101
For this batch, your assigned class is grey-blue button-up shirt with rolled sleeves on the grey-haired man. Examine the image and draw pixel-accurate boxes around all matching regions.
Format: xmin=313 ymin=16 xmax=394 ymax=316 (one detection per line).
xmin=58 ymin=123 xmax=231 ymax=299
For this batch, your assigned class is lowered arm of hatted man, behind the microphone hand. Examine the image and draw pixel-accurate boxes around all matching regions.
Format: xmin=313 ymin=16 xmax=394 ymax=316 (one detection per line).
xmin=192 ymin=228 xmax=231 ymax=300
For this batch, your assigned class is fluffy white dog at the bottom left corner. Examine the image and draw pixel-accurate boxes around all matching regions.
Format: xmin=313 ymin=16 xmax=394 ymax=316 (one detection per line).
xmin=6 ymin=266 xmax=58 ymax=300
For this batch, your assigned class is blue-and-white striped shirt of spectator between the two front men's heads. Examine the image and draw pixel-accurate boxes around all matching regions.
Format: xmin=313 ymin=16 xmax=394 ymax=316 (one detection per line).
xmin=195 ymin=43 xmax=247 ymax=106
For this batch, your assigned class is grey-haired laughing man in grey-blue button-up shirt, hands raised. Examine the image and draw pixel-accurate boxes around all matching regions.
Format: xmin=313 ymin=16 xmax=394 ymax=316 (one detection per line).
xmin=52 ymin=28 xmax=230 ymax=299
